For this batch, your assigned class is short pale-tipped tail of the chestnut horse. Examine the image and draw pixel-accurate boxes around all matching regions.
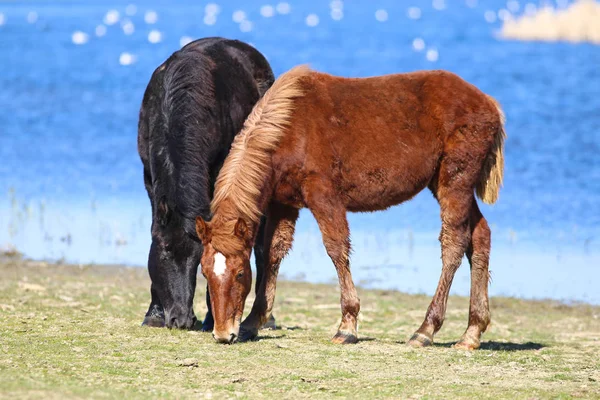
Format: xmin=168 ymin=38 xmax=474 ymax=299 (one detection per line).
xmin=476 ymin=96 xmax=506 ymax=204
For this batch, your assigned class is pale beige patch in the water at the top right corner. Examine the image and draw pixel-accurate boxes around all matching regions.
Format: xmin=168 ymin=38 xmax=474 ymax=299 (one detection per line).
xmin=501 ymin=0 xmax=600 ymax=44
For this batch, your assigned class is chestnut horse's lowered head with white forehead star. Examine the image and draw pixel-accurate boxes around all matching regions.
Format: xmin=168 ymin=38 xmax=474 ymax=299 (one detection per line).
xmin=196 ymin=217 xmax=253 ymax=343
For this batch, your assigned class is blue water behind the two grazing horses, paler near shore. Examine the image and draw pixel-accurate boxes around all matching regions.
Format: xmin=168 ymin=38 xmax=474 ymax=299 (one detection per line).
xmin=0 ymin=0 xmax=600 ymax=303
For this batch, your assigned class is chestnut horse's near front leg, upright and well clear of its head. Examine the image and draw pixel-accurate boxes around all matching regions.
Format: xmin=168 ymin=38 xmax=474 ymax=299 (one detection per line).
xmin=306 ymin=180 xmax=360 ymax=344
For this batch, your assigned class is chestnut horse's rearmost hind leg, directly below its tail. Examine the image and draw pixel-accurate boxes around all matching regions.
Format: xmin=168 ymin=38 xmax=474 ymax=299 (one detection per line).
xmin=455 ymin=201 xmax=491 ymax=350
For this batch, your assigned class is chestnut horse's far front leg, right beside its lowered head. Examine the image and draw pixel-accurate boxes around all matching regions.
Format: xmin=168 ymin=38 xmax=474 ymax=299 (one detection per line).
xmin=239 ymin=203 xmax=298 ymax=341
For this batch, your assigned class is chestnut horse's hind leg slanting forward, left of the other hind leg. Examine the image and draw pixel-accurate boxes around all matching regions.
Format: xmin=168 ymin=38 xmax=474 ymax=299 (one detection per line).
xmin=408 ymin=185 xmax=474 ymax=347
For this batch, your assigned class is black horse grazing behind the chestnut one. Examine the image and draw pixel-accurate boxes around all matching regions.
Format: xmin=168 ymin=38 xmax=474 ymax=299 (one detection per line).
xmin=138 ymin=38 xmax=274 ymax=330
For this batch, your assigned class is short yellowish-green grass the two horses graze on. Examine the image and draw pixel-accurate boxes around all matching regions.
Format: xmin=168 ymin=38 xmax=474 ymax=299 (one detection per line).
xmin=0 ymin=257 xmax=600 ymax=399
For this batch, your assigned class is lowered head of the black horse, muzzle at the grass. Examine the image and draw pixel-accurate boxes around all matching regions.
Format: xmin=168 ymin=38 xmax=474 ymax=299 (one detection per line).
xmin=148 ymin=198 xmax=202 ymax=329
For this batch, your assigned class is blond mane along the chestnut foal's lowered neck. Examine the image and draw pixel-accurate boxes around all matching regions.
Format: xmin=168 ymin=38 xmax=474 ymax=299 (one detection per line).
xmin=211 ymin=66 xmax=311 ymax=223
